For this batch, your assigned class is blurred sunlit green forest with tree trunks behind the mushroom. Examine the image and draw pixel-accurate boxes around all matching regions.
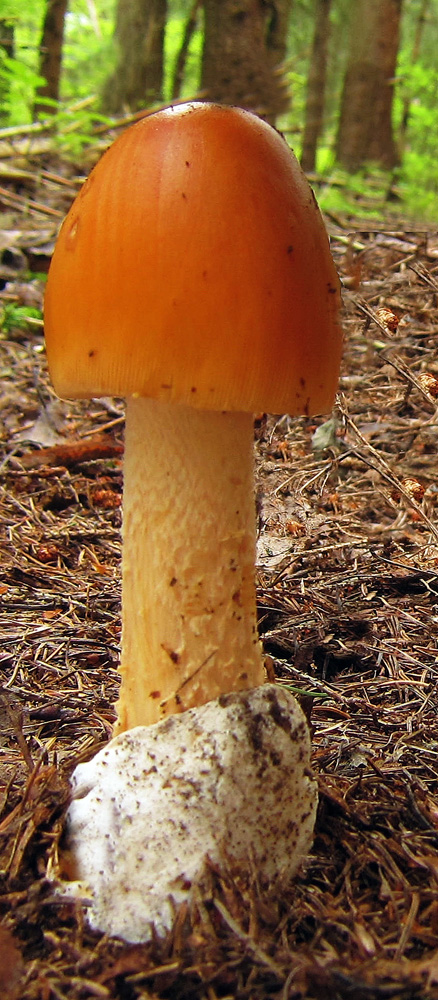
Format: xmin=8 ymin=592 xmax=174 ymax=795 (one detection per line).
xmin=0 ymin=0 xmax=438 ymax=223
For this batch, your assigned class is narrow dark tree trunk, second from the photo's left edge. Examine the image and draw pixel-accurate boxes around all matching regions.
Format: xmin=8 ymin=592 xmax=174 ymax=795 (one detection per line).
xmin=33 ymin=0 xmax=68 ymax=117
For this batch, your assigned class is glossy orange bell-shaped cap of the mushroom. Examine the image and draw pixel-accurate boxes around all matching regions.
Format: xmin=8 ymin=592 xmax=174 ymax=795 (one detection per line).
xmin=45 ymin=103 xmax=342 ymax=414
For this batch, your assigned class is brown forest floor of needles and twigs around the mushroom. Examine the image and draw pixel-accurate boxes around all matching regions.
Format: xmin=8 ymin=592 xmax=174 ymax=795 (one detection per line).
xmin=0 ymin=143 xmax=438 ymax=1000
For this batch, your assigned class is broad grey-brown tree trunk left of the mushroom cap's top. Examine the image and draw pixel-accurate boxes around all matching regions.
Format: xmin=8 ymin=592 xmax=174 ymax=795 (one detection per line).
xmin=102 ymin=0 xmax=167 ymax=114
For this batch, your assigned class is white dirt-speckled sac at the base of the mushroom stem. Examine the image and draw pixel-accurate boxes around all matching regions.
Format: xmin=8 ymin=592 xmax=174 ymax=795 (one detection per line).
xmin=62 ymin=684 xmax=317 ymax=942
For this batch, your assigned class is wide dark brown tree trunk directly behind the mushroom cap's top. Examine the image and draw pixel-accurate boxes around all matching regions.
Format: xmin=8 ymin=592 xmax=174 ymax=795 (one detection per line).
xmin=201 ymin=0 xmax=292 ymax=124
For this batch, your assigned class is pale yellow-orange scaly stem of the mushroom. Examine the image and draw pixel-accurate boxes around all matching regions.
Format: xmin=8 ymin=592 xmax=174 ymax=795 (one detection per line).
xmin=116 ymin=397 xmax=264 ymax=732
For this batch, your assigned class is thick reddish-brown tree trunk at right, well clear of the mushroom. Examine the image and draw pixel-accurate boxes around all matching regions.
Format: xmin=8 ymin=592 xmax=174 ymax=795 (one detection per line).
xmin=336 ymin=0 xmax=402 ymax=171
